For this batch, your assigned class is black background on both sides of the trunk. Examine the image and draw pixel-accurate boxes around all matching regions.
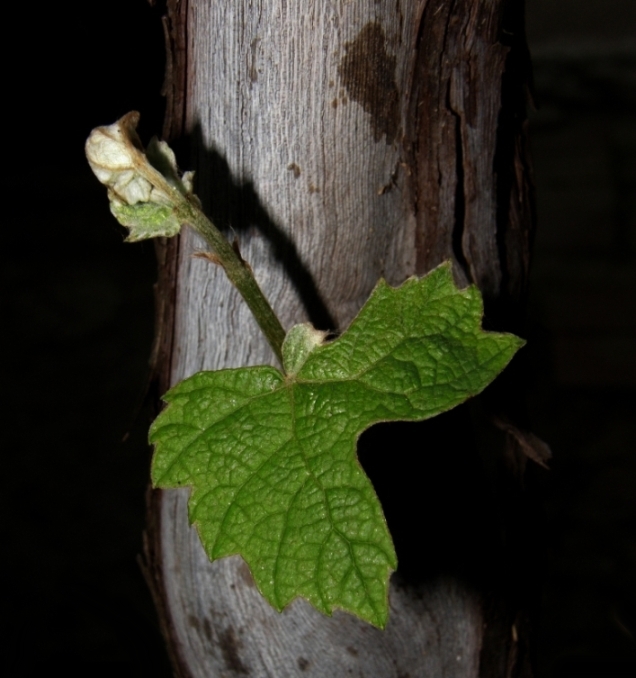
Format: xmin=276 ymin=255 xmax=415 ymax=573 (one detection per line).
xmin=0 ymin=0 xmax=636 ymax=678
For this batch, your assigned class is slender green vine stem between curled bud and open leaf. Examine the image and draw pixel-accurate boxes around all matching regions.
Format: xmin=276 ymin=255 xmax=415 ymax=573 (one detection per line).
xmin=175 ymin=196 xmax=285 ymax=365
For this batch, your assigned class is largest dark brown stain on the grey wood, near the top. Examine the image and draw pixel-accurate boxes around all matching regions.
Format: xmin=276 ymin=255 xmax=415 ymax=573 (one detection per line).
xmin=338 ymin=21 xmax=400 ymax=144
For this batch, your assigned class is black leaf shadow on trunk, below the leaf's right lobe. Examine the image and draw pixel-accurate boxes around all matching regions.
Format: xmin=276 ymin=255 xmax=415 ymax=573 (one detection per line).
xmin=358 ymin=407 xmax=495 ymax=588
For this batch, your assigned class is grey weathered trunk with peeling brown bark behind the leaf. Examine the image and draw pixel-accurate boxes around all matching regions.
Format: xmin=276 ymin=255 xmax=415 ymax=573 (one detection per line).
xmin=146 ymin=0 xmax=534 ymax=678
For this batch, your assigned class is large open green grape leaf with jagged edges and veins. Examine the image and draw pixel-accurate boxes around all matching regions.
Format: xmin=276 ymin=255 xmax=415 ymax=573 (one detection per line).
xmin=150 ymin=264 xmax=523 ymax=628
